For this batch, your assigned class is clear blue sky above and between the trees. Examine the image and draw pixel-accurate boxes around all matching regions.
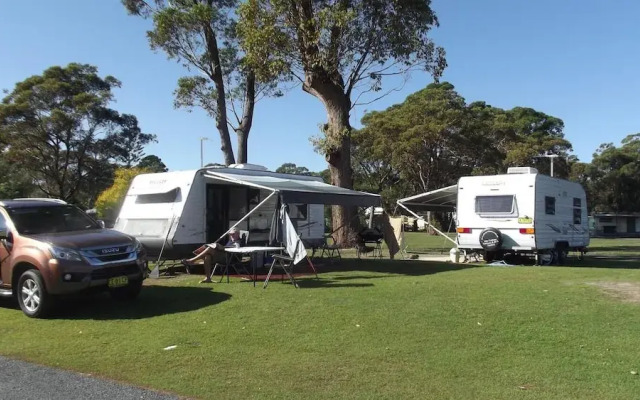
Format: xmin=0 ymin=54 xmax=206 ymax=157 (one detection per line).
xmin=0 ymin=0 xmax=640 ymax=171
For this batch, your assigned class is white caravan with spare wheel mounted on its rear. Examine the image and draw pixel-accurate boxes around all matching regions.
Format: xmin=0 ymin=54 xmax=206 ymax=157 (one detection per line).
xmin=456 ymin=167 xmax=589 ymax=264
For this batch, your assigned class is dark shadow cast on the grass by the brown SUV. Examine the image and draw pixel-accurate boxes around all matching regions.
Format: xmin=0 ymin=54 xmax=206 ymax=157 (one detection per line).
xmin=51 ymin=286 xmax=231 ymax=320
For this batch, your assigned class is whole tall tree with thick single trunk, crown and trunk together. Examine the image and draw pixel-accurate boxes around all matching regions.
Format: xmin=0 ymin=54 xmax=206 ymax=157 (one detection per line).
xmin=238 ymin=0 xmax=446 ymax=243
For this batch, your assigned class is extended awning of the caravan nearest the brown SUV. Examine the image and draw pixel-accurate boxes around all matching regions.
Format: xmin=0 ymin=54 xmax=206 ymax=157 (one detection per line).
xmin=205 ymin=170 xmax=381 ymax=207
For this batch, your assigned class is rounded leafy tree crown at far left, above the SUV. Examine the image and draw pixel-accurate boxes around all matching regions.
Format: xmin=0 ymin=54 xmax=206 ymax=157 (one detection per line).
xmin=0 ymin=63 xmax=155 ymax=204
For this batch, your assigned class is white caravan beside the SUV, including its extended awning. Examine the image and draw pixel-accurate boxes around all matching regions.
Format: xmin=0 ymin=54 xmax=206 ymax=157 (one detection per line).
xmin=114 ymin=164 xmax=380 ymax=259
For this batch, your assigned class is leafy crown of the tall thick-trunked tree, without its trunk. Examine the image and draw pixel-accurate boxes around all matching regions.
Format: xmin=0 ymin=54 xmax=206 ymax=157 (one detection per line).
xmin=238 ymin=0 xmax=446 ymax=98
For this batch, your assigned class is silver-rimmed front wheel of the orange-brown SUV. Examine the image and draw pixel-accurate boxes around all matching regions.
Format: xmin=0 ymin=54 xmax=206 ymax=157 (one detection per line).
xmin=16 ymin=269 xmax=53 ymax=318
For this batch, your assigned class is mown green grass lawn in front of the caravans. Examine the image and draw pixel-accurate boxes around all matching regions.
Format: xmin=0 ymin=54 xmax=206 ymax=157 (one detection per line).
xmin=0 ymin=239 xmax=640 ymax=399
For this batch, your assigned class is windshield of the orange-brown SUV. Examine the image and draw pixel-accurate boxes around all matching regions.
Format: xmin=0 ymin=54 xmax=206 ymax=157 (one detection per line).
xmin=7 ymin=206 xmax=100 ymax=235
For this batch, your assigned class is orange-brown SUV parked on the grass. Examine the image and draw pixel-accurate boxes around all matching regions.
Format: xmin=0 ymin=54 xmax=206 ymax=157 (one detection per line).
xmin=0 ymin=199 xmax=147 ymax=317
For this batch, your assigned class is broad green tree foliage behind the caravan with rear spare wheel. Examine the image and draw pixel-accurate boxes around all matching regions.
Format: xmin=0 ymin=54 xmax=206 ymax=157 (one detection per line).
xmin=353 ymin=82 xmax=571 ymax=207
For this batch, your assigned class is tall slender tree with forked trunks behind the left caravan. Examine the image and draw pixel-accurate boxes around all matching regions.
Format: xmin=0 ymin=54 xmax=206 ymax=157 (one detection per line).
xmin=122 ymin=0 xmax=280 ymax=165
